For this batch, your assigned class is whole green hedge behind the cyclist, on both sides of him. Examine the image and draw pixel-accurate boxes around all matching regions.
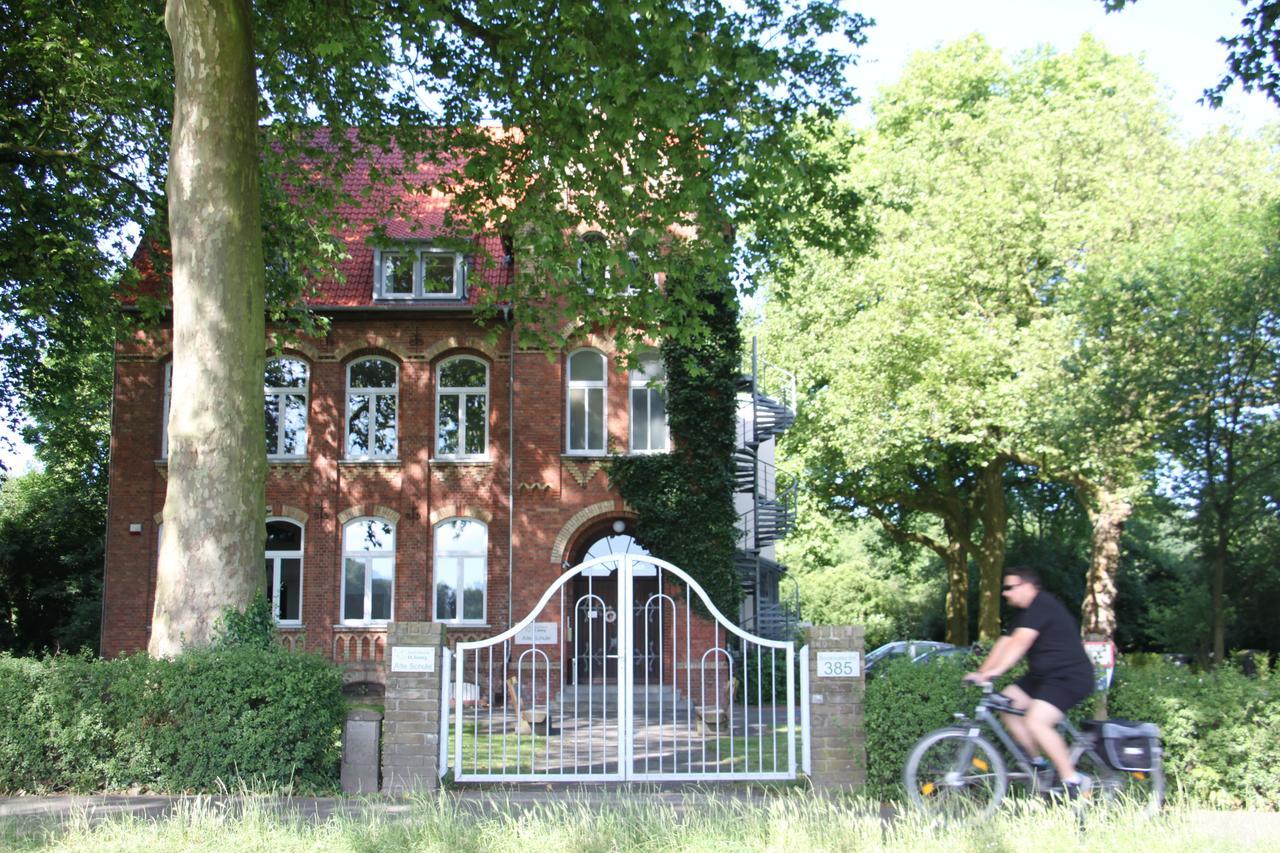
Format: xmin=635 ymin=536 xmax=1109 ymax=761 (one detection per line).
xmin=864 ymin=648 xmax=1280 ymax=809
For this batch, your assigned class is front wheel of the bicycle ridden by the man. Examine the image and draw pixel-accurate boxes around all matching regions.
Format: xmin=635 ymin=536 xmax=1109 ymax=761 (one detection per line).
xmin=902 ymin=729 xmax=1009 ymax=820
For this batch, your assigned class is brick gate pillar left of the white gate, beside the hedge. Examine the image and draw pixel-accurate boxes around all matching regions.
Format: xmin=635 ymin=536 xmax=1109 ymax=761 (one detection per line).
xmin=383 ymin=622 xmax=444 ymax=794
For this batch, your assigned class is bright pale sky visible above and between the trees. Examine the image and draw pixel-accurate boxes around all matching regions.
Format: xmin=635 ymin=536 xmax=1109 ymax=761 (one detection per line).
xmin=0 ymin=0 xmax=1280 ymax=473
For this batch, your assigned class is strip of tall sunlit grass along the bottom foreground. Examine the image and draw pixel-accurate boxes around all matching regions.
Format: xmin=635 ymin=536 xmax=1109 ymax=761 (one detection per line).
xmin=0 ymin=792 xmax=1275 ymax=853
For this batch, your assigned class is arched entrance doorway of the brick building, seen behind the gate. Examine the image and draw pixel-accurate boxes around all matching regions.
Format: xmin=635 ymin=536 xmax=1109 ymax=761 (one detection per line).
xmin=568 ymin=519 xmax=662 ymax=684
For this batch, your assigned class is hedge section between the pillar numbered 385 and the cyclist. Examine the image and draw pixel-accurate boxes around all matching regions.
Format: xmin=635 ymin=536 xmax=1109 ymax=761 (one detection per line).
xmin=863 ymin=656 xmax=983 ymax=799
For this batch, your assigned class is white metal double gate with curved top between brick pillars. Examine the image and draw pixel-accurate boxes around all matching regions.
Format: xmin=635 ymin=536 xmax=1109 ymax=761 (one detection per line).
xmin=440 ymin=555 xmax=797 ymax=781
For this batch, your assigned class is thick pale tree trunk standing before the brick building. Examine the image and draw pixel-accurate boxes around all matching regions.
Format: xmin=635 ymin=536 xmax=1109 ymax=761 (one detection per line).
xmin=147 ymin=0 xmax=266 ymax=657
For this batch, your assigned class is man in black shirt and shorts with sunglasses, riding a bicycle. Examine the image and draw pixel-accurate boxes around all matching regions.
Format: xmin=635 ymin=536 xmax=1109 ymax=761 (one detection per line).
xmin=965 ymin=567 xmax=1093 ymax=798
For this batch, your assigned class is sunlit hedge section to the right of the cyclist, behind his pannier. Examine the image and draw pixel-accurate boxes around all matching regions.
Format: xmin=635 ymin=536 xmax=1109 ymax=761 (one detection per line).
xmin=1108 ymin=661 xmax=1280 ymax=808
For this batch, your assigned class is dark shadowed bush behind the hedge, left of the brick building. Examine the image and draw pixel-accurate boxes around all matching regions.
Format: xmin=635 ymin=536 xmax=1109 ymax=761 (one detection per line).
xmin=0 ymin=470 xmax=106 ymax=654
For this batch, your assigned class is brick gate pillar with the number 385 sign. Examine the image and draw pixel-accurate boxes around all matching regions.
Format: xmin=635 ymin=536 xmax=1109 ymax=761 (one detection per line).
xmin=805 ymin=625 xmax=867 ymax=789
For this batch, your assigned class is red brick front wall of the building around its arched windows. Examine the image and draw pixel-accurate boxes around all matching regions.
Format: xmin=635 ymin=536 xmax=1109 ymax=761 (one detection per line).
xmin=102 ymin=311 xmax=640 ymax=679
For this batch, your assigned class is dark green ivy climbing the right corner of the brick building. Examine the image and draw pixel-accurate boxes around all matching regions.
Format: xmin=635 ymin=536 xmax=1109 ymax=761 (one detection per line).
xmin=609 ymin=273 xmax=742 ymax=617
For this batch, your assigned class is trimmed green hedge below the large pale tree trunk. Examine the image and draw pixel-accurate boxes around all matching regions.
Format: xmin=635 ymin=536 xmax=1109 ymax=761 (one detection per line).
xmin=0 ymin=646 xmax=346 ymax=792
